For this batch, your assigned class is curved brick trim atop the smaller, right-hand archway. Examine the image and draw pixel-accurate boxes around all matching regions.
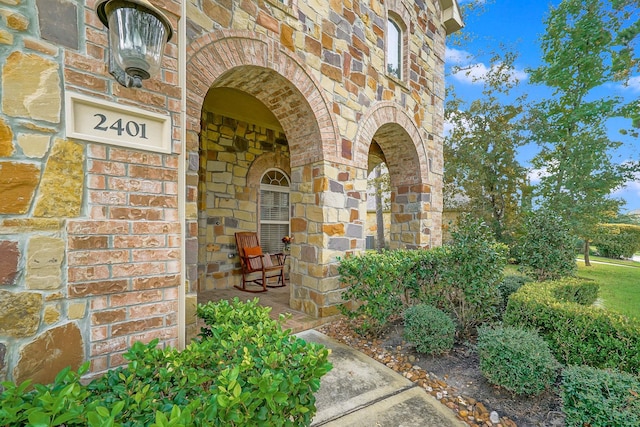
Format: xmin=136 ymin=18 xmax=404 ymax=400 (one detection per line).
xmin=354 ymin=102 xmax=429 ymax=185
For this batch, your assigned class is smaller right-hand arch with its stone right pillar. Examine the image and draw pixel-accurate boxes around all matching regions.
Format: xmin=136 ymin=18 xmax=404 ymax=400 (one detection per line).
xmin=356 ymin=103 xmax=437 ymax=249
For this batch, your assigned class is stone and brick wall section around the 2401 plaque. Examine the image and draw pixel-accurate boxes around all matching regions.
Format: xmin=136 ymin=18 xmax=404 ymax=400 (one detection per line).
xmin=0 ymin=0 xmax=181 ymax=382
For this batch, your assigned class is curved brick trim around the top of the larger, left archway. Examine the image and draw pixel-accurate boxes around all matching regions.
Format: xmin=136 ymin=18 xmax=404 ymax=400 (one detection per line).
xmin=186 ymin=30 xmax=342 ymax=166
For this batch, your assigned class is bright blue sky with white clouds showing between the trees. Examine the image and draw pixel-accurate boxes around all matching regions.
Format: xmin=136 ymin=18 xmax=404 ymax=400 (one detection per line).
xmin=446 ymin=0 xmax=640 ymax=212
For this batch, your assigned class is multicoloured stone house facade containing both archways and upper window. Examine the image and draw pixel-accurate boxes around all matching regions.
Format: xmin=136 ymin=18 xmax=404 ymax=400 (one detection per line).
xmin=182 ymin=0 xmax=457 ymax=316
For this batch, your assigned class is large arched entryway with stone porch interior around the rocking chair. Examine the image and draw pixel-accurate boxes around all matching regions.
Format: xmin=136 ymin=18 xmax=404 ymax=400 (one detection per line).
xmin=187 ymin=31 xmax=340 ymax=324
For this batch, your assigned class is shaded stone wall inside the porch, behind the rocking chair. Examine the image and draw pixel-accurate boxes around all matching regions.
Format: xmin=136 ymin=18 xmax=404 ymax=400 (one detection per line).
xmin=198 ymin=109 xmax=290 ymax=290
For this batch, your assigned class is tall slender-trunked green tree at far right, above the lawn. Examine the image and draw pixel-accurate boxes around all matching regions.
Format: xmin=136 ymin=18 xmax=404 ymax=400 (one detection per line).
xmin=531 ymin=0 xmax=640 ymax=264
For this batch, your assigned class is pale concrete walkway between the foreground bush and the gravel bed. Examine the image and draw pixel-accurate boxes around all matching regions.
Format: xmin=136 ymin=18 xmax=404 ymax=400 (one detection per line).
xmin=296 ymin=330 xmax=466 ymax=427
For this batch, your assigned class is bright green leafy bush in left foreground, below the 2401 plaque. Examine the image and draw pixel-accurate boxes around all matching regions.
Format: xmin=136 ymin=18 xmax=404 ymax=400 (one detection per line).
xmin=0 ymin=298 xmax=331 ymax=427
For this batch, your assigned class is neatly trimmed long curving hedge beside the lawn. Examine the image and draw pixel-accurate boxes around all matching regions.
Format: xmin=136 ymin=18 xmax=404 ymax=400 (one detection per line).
xmin=503 ymin=278 xmax=640 ymax=375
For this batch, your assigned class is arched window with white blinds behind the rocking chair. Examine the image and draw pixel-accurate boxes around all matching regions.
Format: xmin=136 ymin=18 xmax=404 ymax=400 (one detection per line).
xmin=260 ymin=169 xmax=290 ymax=253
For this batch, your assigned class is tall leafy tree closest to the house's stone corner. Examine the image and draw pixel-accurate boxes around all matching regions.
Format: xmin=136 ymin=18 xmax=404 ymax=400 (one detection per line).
xmin=444 ymin=53 xmax=528 ymax=243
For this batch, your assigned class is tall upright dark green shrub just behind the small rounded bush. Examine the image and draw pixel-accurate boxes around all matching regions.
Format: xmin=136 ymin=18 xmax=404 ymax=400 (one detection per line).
xmin=434 ymin=216 xmax=507 ymax=337
